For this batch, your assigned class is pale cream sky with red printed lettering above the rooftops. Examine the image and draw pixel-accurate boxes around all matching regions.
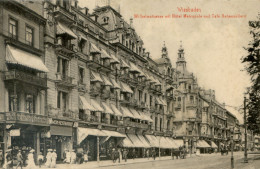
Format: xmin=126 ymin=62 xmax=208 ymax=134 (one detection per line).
xmin=79 ymin=0 xmax=260 ymax=106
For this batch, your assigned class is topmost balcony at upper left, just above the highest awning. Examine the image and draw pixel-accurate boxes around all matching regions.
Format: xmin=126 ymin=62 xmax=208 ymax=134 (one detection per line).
xmin=53 ymin=6 xmax=75 ymax=23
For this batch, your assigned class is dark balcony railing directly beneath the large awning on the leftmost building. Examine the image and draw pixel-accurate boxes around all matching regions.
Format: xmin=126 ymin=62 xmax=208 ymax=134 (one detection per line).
xmin=4 ymin=70 xmax=47 ymax=88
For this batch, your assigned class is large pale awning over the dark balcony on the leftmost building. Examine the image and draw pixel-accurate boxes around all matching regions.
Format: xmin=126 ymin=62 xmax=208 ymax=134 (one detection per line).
xmin=6 ymin=45 xmax=49 ymax=72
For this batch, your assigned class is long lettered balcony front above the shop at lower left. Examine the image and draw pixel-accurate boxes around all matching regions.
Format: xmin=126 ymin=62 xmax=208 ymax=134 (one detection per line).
xmin=0 ymin=112 xmax=50 ymax=126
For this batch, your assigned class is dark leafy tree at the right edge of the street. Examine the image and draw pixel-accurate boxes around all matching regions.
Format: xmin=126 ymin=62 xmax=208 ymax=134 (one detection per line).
xmin=242 ymin=15 xmax=260 ymax=134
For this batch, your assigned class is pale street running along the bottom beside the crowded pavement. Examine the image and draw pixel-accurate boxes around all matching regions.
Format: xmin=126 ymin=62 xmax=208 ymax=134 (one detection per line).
xmin=38 ymin=152 xmax=260 ymax=169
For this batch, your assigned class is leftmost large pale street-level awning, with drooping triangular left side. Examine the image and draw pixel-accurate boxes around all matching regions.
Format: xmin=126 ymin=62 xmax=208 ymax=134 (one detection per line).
xmin=77 ymin=127 xmax=107 ymax=144
